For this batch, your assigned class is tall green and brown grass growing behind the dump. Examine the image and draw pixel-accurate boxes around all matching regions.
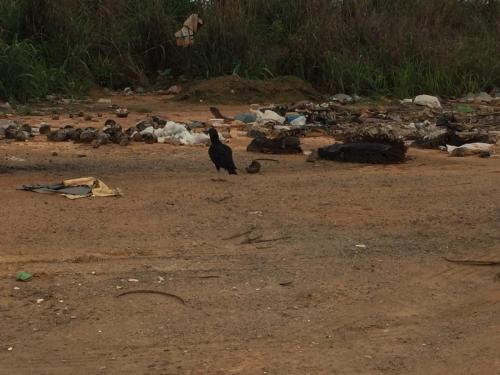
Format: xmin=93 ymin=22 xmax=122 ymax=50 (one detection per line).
xmin=0 ymin=0 xmax=500 ymax=100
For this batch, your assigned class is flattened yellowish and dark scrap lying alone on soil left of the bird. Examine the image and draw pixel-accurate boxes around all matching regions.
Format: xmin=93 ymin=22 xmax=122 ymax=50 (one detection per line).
xmin=17 ymin=177 xmax=121 ymax=199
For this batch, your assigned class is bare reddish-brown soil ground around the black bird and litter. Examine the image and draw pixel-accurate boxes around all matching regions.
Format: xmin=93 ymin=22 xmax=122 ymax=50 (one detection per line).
xmin=0 ymin=97 xmax=500 ymax=375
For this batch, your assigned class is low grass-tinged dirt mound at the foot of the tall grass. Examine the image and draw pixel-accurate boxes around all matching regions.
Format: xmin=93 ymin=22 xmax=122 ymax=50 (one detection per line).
xmin=177 ymin=76 xmax=318 ymax=104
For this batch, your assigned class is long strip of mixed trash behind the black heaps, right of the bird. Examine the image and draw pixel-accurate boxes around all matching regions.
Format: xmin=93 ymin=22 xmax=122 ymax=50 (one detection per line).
xmin=212 ymin=93 xmax=500 ymax=158
